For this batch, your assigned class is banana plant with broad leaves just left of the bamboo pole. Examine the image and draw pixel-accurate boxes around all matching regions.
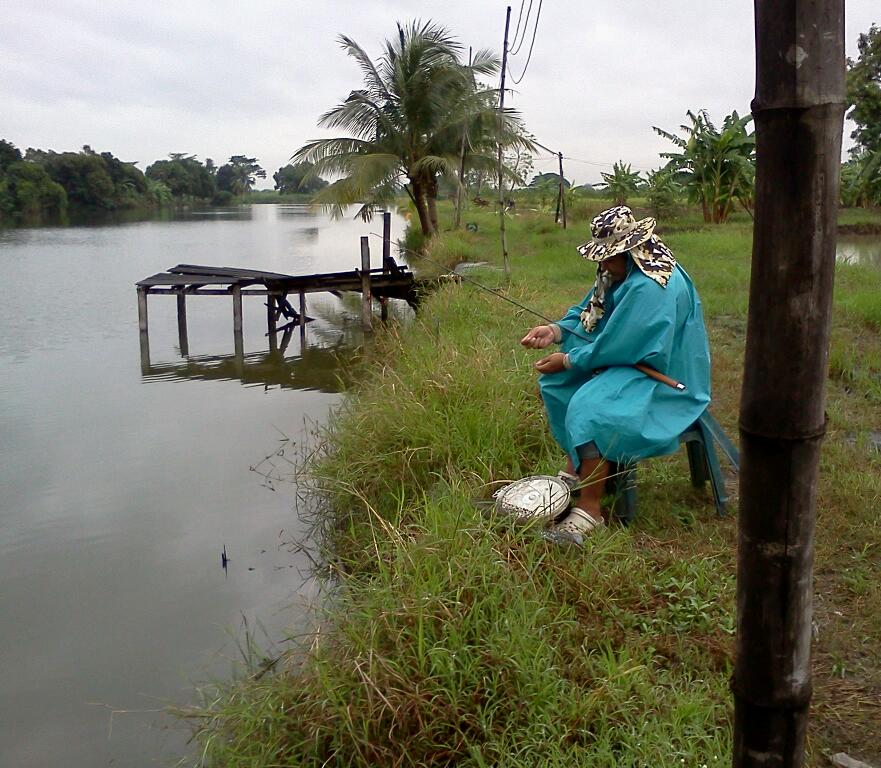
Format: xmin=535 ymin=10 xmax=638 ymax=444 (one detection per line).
xmin=654 ymin=110 xmax=756 ymax=224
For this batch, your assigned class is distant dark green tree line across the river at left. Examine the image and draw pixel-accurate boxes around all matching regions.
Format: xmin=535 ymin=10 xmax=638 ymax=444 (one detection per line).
xmin=0 ymin=139 xmax=327 ymax=224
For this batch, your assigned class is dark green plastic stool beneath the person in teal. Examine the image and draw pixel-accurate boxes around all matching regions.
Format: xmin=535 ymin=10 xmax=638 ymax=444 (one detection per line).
xmin=606 ymin=410 xmax=740 ymax=525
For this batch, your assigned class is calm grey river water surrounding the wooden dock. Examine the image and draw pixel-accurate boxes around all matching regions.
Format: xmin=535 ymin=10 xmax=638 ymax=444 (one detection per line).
xmin=0 ymin=205 xmax=404 ymax=768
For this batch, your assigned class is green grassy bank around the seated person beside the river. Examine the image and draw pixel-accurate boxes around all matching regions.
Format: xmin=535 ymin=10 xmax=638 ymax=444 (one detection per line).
xmin=186 ymin=202 xmax=881 ymax=768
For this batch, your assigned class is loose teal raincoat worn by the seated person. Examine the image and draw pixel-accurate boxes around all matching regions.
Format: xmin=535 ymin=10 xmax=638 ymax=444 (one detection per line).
xmin=539 ymin=257 xmax=710 ymax=467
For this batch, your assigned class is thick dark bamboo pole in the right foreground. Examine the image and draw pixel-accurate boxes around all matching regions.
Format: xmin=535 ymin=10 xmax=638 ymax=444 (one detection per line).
xmin=732 ymin=0 xmax=845 ymax=768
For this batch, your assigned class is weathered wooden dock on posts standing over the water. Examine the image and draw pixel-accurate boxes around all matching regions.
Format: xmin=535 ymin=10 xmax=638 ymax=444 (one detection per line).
xmin=136 ymin=214 xmax=420 ymax=367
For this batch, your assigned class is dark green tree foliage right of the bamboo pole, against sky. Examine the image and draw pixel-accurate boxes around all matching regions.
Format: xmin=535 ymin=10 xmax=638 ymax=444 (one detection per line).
xmin=846 ymin=24 xmax=881 ymax=155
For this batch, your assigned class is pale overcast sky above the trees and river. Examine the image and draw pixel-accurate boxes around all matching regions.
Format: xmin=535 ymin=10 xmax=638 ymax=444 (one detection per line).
xmin=0 ymin=0 xmax=881 ymax=186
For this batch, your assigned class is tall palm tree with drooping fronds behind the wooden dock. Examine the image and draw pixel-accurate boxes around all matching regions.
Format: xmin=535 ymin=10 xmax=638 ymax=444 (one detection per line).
xmin=291 ymin=22 xmax=531 ymax=235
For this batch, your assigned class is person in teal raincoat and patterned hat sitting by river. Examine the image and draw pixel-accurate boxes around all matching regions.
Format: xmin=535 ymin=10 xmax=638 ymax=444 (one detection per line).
xmin=520 ymin=205 xmax=710 ymax=544
